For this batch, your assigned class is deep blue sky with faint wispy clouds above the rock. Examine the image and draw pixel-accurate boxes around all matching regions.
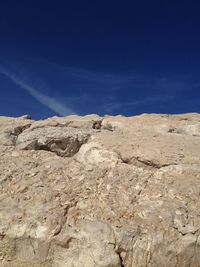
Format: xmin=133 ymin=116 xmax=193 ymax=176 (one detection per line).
xmin=0 ymin=0 xmax=200 ymax=119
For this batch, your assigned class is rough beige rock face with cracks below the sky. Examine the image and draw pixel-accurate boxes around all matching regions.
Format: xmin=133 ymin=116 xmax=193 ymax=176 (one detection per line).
xmin=0 ymin=113 xmax=200 ymax=267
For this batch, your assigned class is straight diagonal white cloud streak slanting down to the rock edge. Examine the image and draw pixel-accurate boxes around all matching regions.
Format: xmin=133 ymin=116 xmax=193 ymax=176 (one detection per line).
xmin=0 ymin=66 xmax=76 ymax=116
